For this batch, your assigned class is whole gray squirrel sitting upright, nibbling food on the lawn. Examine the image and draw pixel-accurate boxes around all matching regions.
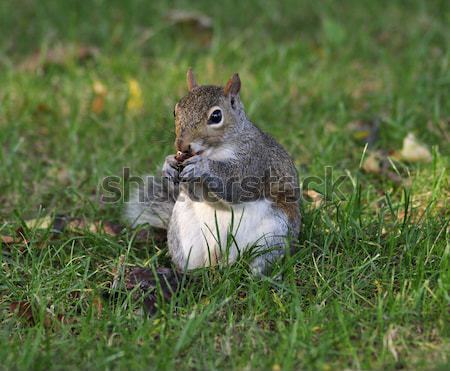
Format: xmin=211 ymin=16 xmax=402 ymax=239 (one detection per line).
xmin=125 ymin=69 xmax=300 ymax=275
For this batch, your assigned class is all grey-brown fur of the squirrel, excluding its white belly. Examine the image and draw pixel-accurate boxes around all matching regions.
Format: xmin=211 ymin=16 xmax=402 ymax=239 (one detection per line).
xmin=126 ymin=75 xmax=300 ymax=274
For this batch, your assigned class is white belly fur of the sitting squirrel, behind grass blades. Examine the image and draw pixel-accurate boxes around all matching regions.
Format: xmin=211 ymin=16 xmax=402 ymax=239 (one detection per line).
xmin=169 ymin=193 xmax=288 ymax=269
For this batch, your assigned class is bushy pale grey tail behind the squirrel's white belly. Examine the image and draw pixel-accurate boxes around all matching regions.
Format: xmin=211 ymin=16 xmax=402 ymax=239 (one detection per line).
xmin=124 ymin=176 xmax=179 ymax=229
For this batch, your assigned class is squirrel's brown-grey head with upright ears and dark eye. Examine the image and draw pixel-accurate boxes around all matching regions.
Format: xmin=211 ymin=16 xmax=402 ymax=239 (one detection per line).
xmin=174 ymin=69 xmax=243 ymax=157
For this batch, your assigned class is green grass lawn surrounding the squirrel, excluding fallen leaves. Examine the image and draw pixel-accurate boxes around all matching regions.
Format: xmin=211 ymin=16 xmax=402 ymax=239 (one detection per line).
xmin=0 ymin=0 xmax=450 ymax=370
